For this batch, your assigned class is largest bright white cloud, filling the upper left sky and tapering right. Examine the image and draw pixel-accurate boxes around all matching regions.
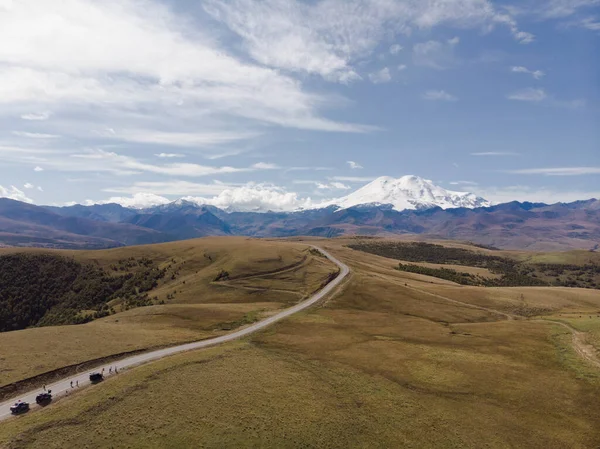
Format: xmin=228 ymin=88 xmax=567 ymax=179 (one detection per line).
xmin=0 ymin=0 xmax=367 ymax=135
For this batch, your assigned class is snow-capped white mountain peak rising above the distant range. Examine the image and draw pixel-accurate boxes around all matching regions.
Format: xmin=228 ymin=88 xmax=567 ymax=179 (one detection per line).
xmin=323 ymin=175 xmax=491 ymax=211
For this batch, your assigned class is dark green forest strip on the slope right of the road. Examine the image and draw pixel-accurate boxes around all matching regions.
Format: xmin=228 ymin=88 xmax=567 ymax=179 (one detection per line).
xmin=348 ymin=241 xmax=600 ymax=289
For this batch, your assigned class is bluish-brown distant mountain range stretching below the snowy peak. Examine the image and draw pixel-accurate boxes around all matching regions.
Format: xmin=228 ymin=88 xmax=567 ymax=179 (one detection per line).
xmin=0 ymin=194 xmax=600 ymax=251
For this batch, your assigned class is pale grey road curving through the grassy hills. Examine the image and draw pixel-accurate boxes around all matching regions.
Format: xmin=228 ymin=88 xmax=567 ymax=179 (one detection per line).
xmin=0 ymin=245 xmax=350 ymax=421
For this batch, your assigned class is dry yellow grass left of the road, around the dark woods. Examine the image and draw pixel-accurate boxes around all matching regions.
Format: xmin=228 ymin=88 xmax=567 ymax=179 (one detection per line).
xmin=0 ymin=238 xmax=335 ymax=386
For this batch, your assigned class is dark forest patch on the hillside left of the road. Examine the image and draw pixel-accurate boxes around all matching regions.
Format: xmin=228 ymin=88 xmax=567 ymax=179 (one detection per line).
xmin=0 ymin=253 xmax=166 ymax=332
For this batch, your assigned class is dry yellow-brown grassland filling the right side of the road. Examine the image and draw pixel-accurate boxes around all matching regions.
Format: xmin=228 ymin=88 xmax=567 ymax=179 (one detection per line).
xmin=0 ymin=236 xmax=600 ymax=449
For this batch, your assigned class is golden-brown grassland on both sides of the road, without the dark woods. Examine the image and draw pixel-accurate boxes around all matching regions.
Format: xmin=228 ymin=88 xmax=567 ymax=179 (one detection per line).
xmin=0 ymin=238 xmax=600 ymax=449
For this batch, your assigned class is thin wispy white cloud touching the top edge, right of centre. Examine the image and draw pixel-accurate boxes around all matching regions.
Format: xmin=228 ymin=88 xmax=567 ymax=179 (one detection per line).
xmin=205 ymin=0 xmax=533 ymax=83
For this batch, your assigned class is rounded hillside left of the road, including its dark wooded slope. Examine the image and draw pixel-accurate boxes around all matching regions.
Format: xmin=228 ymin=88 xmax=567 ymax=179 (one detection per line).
xmin=0 ymin=237 xmax=335 ymax=386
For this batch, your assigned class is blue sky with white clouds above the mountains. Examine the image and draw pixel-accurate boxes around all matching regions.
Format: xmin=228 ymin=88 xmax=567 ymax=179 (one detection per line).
xmin=0 ymin=0 xmax=600 ymax=210
